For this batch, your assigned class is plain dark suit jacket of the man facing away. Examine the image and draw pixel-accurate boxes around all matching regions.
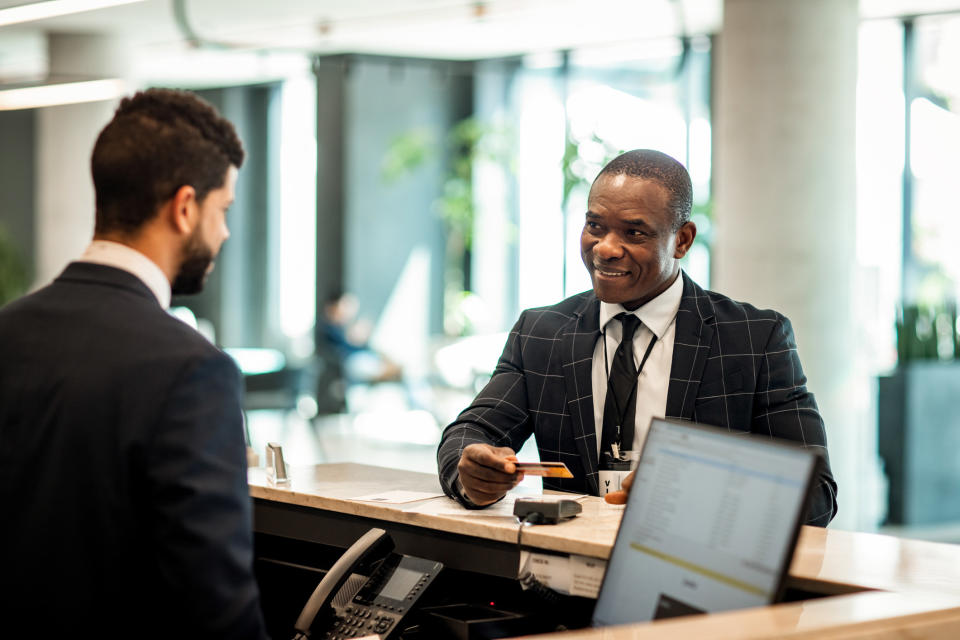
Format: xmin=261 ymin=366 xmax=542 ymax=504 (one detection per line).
xmin=0 ymin=263 xmax=266 ymax=638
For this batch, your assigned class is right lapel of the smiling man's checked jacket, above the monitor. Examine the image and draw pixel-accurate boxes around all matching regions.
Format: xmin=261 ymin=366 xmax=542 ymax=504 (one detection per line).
xmin=666 ymin=272 xmax=714 ymax=420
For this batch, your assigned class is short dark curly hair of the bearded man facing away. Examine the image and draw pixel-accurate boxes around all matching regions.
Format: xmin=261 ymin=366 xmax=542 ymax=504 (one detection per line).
xmin=90 ymin=89 xmax=244 ymax=233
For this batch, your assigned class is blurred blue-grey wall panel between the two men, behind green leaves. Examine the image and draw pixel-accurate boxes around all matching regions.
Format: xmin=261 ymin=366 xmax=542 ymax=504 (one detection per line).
xmin=344 ymin=58 xmax=472 ymax=333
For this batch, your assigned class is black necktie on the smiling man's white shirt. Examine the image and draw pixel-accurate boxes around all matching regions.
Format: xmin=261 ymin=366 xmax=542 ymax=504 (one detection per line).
xmin=600 ymin=313 xmax=640 ymax=453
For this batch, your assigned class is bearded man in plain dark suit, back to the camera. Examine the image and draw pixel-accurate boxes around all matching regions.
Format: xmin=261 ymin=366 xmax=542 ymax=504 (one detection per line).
xmin=0 ymin=89 xmax=266 ymax=638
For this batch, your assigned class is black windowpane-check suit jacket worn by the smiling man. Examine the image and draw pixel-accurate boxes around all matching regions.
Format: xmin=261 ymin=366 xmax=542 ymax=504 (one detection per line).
xmin=437 ymin=274 xmax=837 ymax=526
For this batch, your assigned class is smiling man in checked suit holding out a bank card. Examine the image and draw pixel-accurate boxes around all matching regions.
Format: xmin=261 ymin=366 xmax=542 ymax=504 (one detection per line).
xmin=437 ymin=149 xmax=837 ymax=526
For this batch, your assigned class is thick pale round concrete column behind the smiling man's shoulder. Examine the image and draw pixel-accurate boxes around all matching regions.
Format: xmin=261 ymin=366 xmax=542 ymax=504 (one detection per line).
xmin=712 ymin=0 xmax=876 ymax=528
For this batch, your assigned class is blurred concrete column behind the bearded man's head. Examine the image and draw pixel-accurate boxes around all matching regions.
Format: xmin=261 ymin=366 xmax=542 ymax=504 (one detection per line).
xmin=34 ymin=34 xmax=130 ymax=286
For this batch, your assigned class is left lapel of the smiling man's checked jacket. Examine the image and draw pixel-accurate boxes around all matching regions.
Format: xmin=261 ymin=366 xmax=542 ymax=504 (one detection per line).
xmin=561 ymin=295 xmax=600 ymax=495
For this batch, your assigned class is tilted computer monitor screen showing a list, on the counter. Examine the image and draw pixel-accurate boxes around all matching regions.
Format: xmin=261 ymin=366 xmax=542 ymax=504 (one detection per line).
xmin=593 ymin=419 xmax=817 ymax=626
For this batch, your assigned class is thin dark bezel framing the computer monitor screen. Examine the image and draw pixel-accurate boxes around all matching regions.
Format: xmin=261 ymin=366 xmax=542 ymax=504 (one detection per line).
xmin=590 ymin=417 xmax=823 ymax=626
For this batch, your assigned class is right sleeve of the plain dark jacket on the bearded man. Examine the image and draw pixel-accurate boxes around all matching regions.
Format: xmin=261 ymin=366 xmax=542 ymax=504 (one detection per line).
xmin=145 ymin=351 xmax=266 ymax=638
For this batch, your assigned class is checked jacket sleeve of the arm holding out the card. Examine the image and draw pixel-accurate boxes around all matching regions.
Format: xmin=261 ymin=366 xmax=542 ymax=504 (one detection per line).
xmin=437 ymin=312 xmax=532 ymax=508
